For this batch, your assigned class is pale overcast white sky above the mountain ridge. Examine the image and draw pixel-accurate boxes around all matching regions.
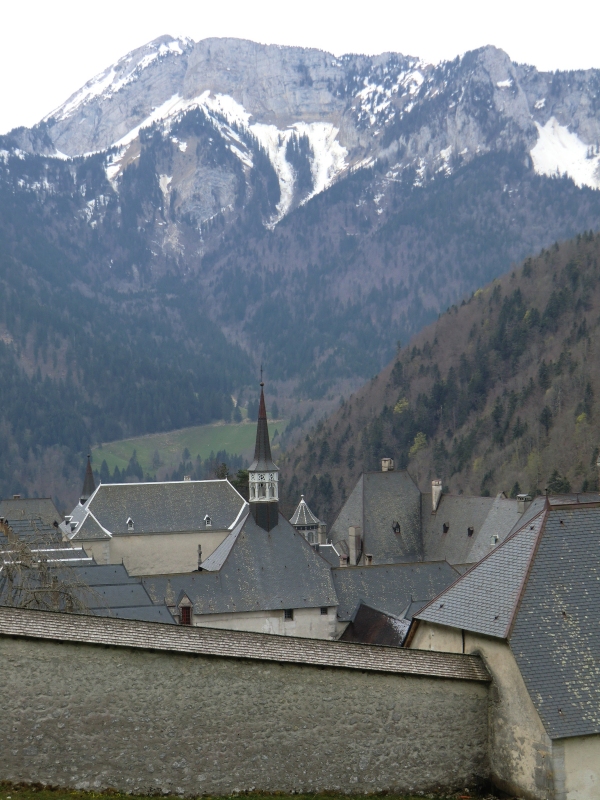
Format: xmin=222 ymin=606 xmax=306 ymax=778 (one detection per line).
xmin=0 ymin=0 xmax=600 ymax=133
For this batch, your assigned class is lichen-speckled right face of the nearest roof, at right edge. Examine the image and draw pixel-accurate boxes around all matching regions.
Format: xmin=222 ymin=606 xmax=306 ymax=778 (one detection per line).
xmin=510 ymin=510 xmax=600 ymax=738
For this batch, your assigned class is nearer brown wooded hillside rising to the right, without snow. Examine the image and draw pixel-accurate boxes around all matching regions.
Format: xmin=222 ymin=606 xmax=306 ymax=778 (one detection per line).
xmin=282 ymin=231 xmax=600 ymax=523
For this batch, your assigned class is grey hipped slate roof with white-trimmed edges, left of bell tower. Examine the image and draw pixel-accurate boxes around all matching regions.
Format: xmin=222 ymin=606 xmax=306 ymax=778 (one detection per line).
xmin=61 ymin=479 xmax=246 ymax=541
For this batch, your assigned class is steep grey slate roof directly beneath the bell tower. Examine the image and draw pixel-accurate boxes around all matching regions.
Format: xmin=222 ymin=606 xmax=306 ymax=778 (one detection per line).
xmin=143 ymin=513 xmax=337 ymax=614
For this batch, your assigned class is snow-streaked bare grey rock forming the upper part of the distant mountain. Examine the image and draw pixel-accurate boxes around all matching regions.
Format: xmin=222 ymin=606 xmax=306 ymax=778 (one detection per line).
xmin=15 ymin=36 xmax=600 ymax=231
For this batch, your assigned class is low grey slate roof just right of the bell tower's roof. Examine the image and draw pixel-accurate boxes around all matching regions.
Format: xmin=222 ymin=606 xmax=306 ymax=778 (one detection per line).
xmin=331 ymin=561 xmax=458 ymax=621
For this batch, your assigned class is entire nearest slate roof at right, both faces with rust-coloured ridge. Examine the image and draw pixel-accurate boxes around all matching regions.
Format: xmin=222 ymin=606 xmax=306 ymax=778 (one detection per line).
xmin=416 ymin=495 xmax=600 ymax=739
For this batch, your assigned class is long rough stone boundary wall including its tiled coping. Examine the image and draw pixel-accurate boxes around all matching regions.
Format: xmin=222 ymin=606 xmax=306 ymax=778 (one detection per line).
xmin=0 ymin=608 xmax=489 ymax=795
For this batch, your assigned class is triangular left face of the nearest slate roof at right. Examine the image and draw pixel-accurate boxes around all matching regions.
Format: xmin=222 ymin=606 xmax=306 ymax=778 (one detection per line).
xmin=415 ymin=514 xmax=543 ymax=638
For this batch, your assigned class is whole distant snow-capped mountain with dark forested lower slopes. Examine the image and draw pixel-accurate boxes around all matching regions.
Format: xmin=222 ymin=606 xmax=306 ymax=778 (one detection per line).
xmin=0 ymin=36 xmax=600 ymax=501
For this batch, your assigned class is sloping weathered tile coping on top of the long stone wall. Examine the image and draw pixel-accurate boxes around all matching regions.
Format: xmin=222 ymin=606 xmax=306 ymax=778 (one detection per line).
xmin=0 ymin=608 xmax=490 ymax=682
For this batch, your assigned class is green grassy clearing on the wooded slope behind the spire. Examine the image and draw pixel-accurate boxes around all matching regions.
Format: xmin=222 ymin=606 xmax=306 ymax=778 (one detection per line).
xmin=92 ymin=420 xmax=287 ymax=474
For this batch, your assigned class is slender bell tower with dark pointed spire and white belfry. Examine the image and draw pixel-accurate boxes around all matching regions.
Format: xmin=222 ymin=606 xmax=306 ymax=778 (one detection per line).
xmin=248 ymin=375 xmax=279 ymax=531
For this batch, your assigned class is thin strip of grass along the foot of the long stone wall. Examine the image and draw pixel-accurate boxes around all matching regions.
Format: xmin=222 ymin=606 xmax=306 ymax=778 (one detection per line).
xmin=0 ymin=782 xmax=493 ymax=800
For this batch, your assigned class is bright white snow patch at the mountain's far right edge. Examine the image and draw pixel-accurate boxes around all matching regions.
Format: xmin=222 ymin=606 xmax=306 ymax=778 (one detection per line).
xmin=530 ymin=117 xmax=600 ymax=189
